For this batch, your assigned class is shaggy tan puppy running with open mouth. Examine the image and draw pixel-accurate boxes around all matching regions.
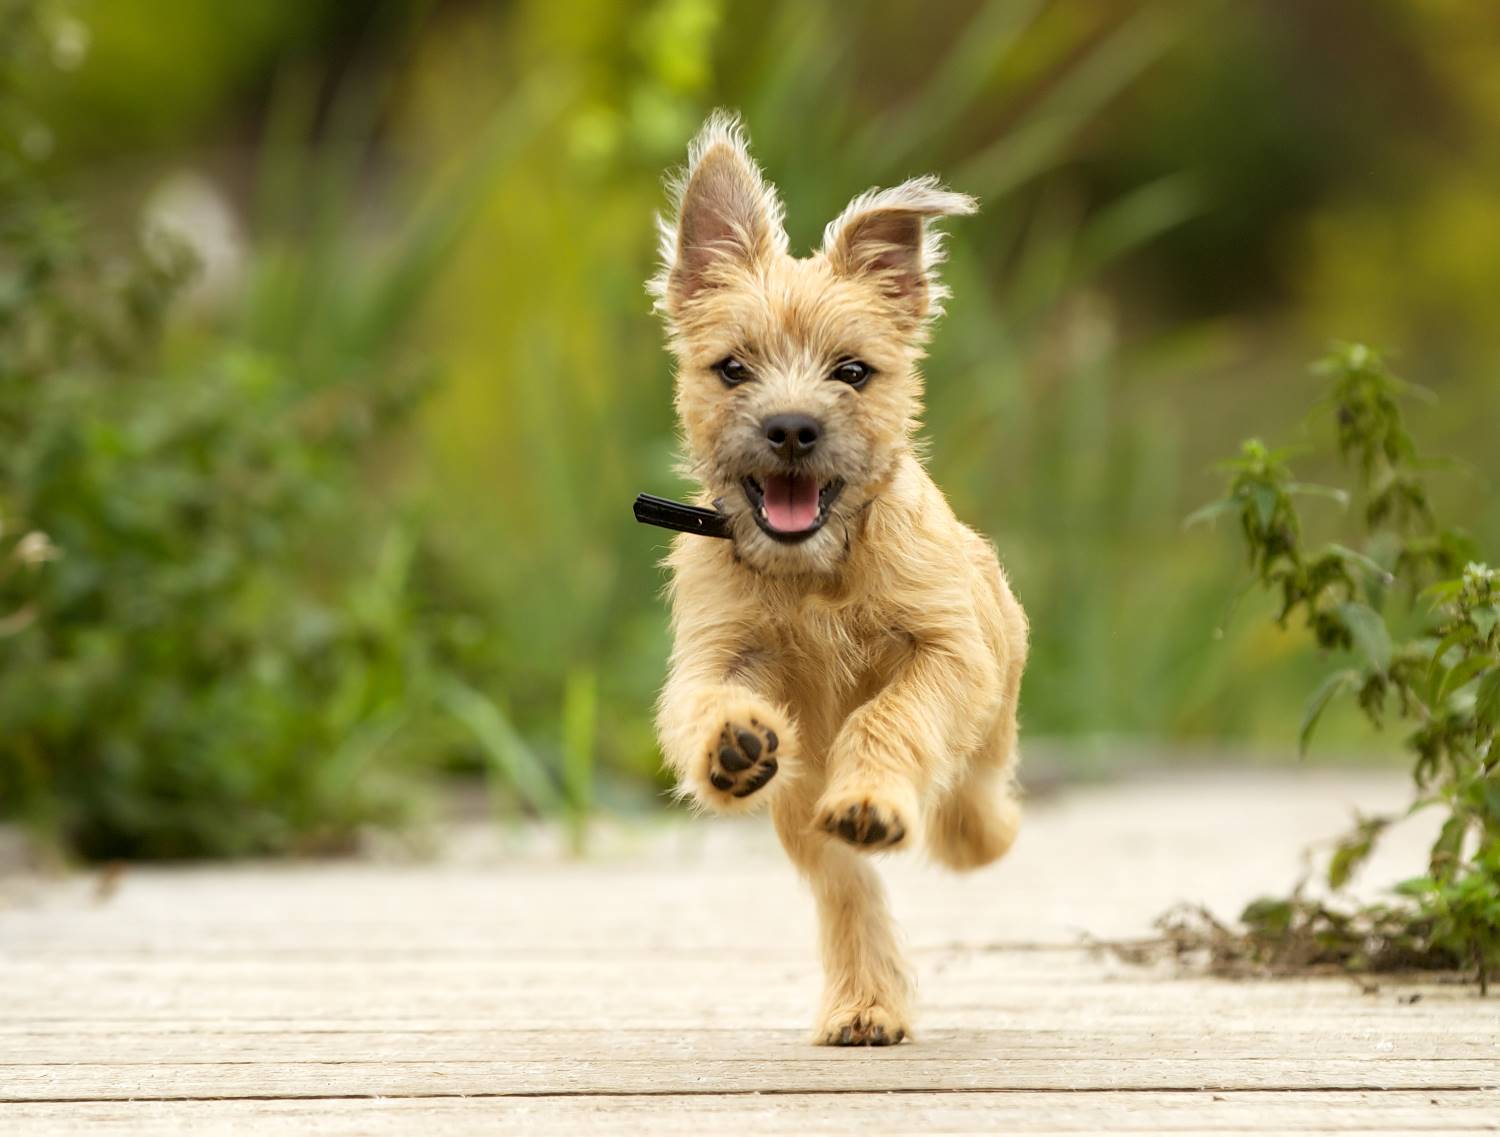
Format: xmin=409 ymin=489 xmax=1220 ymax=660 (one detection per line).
xmin=651 ymin=114 xmax=1026 ymax=1046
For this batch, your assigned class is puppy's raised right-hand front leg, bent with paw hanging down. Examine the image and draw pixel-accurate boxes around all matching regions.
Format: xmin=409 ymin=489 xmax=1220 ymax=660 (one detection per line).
xmin=813 ymin=630 xmax=1001 ymax=851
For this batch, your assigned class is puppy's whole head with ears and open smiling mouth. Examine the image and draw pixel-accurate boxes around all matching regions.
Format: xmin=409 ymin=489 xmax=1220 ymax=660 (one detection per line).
xmin=651 ymin=116 xmax=974 ymax=575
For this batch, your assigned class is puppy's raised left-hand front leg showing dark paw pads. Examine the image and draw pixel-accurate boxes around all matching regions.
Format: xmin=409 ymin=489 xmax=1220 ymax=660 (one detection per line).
xmin=657 ymin=621 xmax=798 ymax=812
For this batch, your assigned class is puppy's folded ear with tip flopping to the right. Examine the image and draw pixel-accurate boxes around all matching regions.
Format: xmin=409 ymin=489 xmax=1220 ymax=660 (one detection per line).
xmin=824 ymin=176 xmax=980 ymax=321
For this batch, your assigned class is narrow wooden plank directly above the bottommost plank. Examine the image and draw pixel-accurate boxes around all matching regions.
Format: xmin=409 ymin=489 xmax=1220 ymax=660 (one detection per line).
xmin=0 ymin=1062 xmax=1500 ymax=1101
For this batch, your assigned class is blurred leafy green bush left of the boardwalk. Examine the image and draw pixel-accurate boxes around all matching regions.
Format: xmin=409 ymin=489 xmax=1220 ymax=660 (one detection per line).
xmin=0 ymin=156 xmax=428 ymax=857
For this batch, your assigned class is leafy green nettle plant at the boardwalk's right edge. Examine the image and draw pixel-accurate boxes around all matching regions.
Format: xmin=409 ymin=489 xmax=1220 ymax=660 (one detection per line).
xmin=1188 ymin=345 xmax=1500 ymax=990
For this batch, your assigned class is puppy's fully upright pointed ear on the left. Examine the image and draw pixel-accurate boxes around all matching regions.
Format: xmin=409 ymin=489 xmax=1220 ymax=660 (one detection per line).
xmin=648 ymin=111 xmax=786 ymax=318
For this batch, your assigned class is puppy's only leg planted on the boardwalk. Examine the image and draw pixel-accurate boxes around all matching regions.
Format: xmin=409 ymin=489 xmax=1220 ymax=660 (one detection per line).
xmin=771 ymin=785 xmax=912 ymax=1046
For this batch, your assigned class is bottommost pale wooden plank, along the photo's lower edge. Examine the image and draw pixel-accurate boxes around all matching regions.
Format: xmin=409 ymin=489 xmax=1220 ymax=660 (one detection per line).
xmin=0 ymin=1091 xmax=1500 ymax=1137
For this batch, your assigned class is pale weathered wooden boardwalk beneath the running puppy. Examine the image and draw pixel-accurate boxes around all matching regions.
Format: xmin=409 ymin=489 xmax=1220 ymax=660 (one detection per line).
xmin=0 ymin=771 xmax=1500 ymax=1137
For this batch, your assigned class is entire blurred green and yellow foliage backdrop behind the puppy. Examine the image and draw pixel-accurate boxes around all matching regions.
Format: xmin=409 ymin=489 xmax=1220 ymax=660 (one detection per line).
xmin=0 ymin=0 xmax=1500 ymax=858
